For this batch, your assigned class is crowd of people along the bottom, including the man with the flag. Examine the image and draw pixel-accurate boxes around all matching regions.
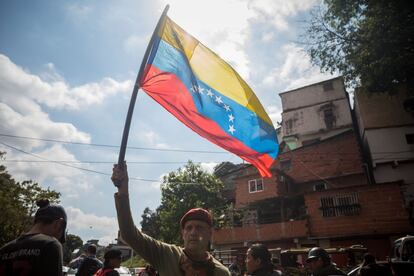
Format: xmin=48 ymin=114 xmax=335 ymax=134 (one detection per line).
xmin=0 ymin=161 xmax=391 ymax=276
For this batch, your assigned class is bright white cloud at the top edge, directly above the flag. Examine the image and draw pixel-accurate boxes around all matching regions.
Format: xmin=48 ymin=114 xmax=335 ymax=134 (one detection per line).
xmin=158 ymin=0 xmax=318 ymax=80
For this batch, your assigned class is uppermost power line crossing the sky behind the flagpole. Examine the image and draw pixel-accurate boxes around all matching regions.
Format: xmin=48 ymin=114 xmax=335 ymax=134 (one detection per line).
xmin=0 ymin=133 xmax=229 ymax=154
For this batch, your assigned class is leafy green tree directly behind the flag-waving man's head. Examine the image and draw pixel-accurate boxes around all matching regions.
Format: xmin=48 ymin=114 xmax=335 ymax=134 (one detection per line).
xmin=143 ymin=161 xmax=226 ymax=244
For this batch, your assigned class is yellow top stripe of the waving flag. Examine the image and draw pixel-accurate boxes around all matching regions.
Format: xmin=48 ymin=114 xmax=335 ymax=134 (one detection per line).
xmin=160 ymin=18 xmax=273 ymax=125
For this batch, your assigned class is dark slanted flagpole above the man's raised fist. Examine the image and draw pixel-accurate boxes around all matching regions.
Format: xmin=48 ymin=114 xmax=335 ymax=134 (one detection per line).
xmin=118 ymin=5 xmax=170 ymax=166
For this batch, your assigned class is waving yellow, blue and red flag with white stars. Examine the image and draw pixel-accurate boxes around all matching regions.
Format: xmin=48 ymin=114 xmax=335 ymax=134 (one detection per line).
xmin=140 ymin=16 xmax=279 ymax=177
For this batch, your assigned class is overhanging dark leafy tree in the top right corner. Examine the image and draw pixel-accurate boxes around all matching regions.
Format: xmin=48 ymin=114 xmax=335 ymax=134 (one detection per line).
xmin=304 ymin=0 xmax=414 ymax=93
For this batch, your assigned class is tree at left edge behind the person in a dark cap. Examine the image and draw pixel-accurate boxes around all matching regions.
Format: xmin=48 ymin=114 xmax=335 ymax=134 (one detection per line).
xmin=0 ymin=152 xmax=60 ymax=246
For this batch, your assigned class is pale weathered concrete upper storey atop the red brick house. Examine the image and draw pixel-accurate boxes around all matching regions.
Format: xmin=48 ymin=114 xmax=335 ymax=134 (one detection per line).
xmin=279 ymin=77 xmax=352 ymax=149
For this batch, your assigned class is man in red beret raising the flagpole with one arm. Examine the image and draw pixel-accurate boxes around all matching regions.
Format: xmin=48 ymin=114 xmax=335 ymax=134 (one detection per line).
xmin=112 ymin=163 xmax=230 ymax=276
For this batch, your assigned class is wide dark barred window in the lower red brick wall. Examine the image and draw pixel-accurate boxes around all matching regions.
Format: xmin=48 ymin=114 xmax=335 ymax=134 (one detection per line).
xmin=320 ymin=193 xmax=361 ymax=217
